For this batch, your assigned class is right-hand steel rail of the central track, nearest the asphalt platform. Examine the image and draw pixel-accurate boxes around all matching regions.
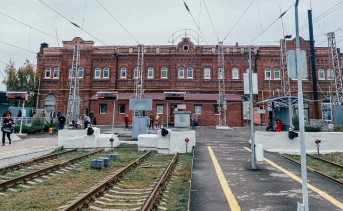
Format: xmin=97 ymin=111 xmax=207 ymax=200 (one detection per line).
xmin=141 ymin=153 xmax=179 ymax=211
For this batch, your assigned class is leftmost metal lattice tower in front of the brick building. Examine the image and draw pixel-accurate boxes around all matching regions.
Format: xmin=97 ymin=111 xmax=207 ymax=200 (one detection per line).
xmin=67 ymin=45 xmax=80 ymax=123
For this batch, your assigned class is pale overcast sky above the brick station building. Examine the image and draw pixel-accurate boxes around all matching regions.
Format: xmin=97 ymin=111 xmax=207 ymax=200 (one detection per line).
xmin=0 ymin=0 xmax=343 ymax=90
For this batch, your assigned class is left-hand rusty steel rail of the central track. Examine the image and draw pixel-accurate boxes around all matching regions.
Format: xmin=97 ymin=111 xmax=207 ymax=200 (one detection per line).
xmin=63 ymin=151 xmax=151 ymax=211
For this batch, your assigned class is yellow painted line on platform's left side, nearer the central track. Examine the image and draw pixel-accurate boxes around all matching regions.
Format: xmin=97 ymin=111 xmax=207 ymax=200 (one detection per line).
xmin=207 ymin=146 xmax=241 ymax=211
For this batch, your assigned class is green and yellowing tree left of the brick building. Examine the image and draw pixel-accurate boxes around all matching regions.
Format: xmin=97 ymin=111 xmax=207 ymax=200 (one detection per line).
xmin=3 ymin=59 xmax=39 ymax=107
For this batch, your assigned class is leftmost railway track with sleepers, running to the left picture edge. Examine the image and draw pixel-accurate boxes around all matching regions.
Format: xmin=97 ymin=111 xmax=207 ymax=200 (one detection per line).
xmin=0 ymin=149 xmax=103 ymax=191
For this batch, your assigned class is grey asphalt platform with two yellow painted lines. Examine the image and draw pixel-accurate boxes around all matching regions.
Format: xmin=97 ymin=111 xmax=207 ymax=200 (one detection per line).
xmin=190 ymin=127 xmax=343 ymax=211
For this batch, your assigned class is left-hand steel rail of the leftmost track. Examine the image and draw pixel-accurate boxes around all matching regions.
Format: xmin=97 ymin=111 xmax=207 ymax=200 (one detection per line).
xmin=0 ymin=149 xmax=76 ymax=174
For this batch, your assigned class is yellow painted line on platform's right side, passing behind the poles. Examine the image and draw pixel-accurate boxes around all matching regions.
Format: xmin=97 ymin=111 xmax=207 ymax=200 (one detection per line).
xmin=244 ymin=147 xmax=343 ymax=210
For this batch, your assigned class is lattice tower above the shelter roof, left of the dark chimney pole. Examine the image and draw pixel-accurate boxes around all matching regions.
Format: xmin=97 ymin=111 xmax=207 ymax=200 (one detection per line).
xmin=280 ymin=39 xmax=291 ymax=96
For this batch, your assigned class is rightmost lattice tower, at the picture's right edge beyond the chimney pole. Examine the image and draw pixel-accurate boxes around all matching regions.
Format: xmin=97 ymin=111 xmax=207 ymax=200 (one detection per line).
xmin=327 ymin=32 xmax=343 ymax=105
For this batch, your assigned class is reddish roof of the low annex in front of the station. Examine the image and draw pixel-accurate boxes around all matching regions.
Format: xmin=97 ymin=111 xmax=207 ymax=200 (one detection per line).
xmin=89 ymin=93 xmax=242 ymax=102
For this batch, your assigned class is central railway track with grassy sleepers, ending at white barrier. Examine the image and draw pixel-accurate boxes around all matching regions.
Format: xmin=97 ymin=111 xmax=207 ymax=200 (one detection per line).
xmin=60 ymin=152 xmax=178 ymax=211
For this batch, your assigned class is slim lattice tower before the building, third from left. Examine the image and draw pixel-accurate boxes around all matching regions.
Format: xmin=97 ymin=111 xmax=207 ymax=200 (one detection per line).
xmin=218 ymin=42 xmax=226 ymax=127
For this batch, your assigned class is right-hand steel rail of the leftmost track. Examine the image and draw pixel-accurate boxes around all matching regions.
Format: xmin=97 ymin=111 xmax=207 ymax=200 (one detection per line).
xmin=0 ymin=149 xmax=103 ymax=191
